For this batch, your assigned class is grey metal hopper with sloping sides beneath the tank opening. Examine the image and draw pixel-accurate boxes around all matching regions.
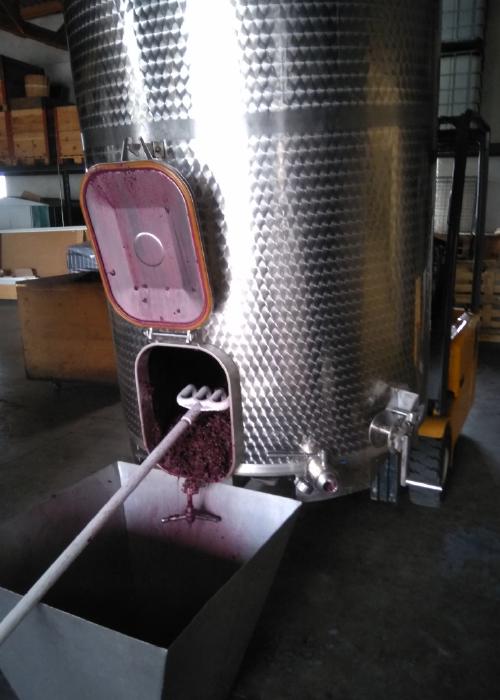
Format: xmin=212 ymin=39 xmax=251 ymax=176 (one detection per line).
xmin=0 ymin=462 xmax=299 ymax=700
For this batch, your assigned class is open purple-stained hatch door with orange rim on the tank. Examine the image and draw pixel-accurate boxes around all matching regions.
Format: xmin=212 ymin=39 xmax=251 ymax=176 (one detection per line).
xmin=80 ymin=161 xmax=212 ymax=330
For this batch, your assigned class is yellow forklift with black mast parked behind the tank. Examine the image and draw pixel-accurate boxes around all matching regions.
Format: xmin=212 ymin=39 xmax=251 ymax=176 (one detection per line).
xmin=406 ymin=111 xmax=489 ymax=507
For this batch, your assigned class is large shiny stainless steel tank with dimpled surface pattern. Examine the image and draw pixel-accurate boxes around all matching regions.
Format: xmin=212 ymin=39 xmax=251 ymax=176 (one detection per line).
xmin=65 ymin=0 xmax=439 ymax=498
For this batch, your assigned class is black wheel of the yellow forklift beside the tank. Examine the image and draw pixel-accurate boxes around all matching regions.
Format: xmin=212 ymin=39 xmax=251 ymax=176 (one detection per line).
xmin=408 ymin=432 xmax=451 ymax=508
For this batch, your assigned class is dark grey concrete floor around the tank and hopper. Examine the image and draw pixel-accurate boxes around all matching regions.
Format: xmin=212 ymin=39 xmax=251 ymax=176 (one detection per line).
xmin=0 ymin=303 xmax=500 ymax=700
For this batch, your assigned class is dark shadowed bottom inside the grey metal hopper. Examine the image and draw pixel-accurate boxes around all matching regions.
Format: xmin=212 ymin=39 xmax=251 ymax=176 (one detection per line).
xmin=44 ymin=534 xmax=240 ymax=647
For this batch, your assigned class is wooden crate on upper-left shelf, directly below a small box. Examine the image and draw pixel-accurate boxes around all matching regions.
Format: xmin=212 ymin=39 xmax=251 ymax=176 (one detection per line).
xmin=11 ymin=107 xmax=50 ymax=164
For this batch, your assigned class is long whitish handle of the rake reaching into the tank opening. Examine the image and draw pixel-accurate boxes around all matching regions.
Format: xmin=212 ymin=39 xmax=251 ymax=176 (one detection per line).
xmin=0 ymin=403 xmax=202 ymax=645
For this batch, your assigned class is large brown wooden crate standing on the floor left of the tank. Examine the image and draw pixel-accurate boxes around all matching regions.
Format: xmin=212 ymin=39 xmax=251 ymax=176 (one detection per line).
xmin=17 ymin=273 xmax=116 ymax=383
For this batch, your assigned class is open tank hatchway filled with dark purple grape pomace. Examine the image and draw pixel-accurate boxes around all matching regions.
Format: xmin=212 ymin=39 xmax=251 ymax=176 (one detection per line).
xmin=137 ymin=345 xmax=234 ymax=490
